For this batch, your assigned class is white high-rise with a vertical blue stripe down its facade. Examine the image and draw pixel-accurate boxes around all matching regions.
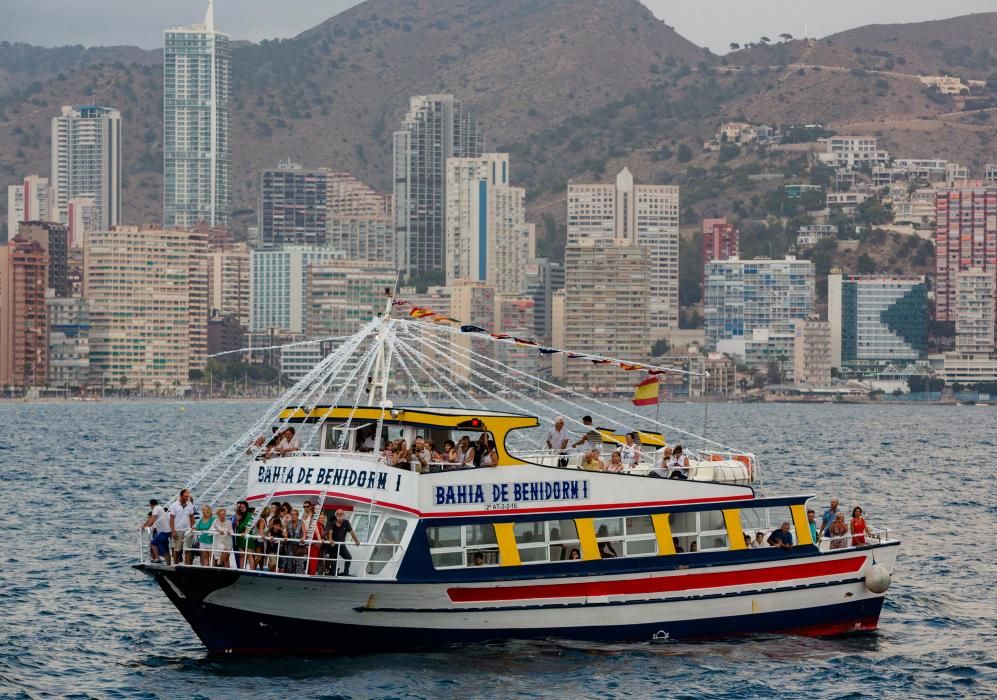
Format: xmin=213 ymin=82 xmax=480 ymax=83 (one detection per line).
xmin=446 ymin=153 xmax=536 ymax=295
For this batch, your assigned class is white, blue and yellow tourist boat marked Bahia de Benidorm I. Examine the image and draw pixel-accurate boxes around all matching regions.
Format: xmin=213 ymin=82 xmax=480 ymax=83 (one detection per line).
xmin=137 ymin=301 xmax=899 ymax=654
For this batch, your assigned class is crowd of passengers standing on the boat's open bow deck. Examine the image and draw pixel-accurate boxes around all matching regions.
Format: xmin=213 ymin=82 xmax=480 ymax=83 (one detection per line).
xmin=142 ymin=489 xmax=374 ymax=576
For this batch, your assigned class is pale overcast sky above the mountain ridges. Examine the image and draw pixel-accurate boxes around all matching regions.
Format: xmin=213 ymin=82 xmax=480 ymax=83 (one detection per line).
xmin=0 ymin=0 xmax=997 ymax=53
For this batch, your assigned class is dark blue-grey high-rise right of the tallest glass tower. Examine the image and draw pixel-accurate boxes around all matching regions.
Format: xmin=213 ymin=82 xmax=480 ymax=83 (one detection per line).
xmin=259 ymin=161 xmax=331 ymax=246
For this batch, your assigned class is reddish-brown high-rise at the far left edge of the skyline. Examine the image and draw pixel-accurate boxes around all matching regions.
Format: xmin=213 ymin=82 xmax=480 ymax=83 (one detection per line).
xmin=0 ymin=236 xmax=49 ymax=387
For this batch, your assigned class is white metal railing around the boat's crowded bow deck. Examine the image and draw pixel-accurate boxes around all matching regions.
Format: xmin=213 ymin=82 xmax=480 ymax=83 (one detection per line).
xmin=139 ymin=528 xmax=404 ymax=578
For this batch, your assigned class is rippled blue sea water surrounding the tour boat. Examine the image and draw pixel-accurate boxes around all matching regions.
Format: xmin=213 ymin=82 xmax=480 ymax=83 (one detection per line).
xmin=0 ymin=402 xmax=997 ymax=700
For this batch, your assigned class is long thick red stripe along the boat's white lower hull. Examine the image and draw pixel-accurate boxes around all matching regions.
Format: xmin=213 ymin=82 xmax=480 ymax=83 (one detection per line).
xmin=447 ymin=556 xmax=865 ymax=603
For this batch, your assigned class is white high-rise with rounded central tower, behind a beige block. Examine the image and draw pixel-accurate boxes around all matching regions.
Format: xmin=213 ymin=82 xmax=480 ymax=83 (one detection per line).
xmin=568 ymin=168 xmax=679 ymax=339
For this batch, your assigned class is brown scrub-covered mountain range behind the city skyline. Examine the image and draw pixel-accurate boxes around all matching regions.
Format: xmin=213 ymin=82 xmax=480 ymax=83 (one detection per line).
xmin=0 ymin=0 xmax=997 ymax=255
